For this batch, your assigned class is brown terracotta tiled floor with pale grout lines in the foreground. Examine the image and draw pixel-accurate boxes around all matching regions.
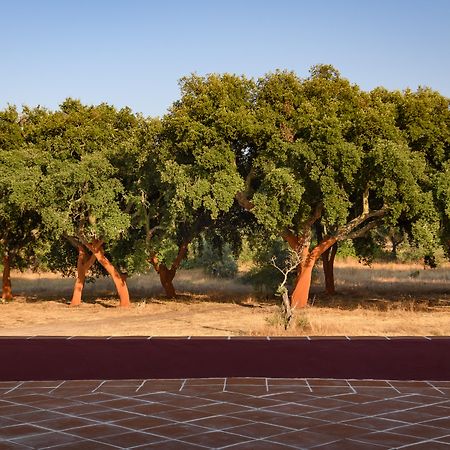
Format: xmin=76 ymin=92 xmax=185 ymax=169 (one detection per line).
xmin=0 ymin=378 xmax=450 ymax=450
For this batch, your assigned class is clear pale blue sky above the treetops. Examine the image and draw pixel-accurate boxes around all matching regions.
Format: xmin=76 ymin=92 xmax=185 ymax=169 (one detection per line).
xmin=0 ymin=0 xmax=450 ymax=116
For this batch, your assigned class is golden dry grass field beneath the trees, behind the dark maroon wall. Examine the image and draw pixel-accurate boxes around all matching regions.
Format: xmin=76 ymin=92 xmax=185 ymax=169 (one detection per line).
xmin=0 ymin=261 xmax=450 ymax=336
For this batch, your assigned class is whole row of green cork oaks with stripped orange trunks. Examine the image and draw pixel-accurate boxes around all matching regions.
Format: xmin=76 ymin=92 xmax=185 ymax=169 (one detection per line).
xmin=0 ymin=65 xmax=450 ymax=308
